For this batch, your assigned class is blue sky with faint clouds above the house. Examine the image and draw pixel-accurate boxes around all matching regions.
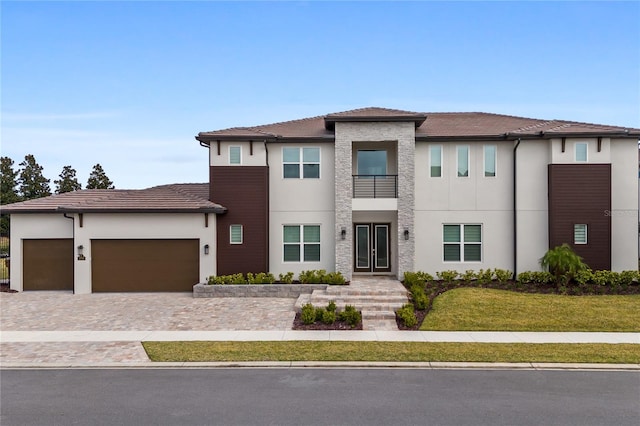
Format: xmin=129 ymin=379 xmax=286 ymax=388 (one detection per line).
xmin=0 ymin=1 xmax=640 ymax=189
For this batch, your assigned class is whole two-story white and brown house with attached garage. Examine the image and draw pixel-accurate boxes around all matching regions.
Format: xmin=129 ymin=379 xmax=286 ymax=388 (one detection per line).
xmin=3 ymin=108 xmax=640 ymax=293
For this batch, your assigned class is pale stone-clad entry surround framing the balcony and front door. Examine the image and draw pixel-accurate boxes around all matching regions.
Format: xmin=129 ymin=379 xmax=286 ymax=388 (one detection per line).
xmin=335 ymin=122 xmax=415 ymax=280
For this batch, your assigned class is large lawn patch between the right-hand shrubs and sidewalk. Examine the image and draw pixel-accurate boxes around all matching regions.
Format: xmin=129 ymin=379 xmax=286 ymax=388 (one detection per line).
xmin=420 ymin=288 xmax=640 ymax=332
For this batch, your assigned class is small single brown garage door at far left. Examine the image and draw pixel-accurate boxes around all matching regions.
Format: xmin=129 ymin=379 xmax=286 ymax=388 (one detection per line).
xmin=22 ymin=238 xmax=73 ymax=291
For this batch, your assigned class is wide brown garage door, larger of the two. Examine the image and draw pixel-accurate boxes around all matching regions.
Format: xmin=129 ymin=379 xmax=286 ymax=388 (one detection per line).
xmin=91 ymin=240 xmax=200 ymax=292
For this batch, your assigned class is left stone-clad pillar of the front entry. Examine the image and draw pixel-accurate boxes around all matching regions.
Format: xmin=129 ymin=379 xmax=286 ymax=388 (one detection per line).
xmin=335 ymin=123 xmax=353 ymax=281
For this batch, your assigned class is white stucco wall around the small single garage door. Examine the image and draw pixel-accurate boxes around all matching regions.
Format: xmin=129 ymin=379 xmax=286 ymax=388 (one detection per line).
xmin=9 ymin=213 xmax=73 ymax=291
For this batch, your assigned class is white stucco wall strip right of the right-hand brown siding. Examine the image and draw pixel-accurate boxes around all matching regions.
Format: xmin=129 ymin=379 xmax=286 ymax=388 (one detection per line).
xmin=604 ymin=139 xmax=638 ymax=271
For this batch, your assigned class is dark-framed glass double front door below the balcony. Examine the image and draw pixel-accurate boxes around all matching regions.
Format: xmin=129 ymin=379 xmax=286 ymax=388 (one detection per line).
xmin=353 ymin=223 xmax=391 ymax=272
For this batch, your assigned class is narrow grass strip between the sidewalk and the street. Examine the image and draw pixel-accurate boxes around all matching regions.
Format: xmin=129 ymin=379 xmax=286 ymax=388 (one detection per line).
xmin=142 ymin=341 xmax=640 ymax=364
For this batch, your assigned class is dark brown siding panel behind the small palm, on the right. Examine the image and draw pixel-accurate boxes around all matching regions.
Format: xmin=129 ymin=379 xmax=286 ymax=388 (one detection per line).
xmin=549 ymin=164 xmax=611 ymax=270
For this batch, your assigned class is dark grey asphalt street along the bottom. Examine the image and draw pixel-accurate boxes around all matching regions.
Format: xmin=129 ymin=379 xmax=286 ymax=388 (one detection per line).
xmin=0 ymin=368 xmax=640 ymax=426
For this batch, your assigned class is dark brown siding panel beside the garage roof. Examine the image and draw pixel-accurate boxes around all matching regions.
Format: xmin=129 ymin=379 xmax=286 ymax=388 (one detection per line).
xmin=209 ymin=166 xmax=269 ymax=275
